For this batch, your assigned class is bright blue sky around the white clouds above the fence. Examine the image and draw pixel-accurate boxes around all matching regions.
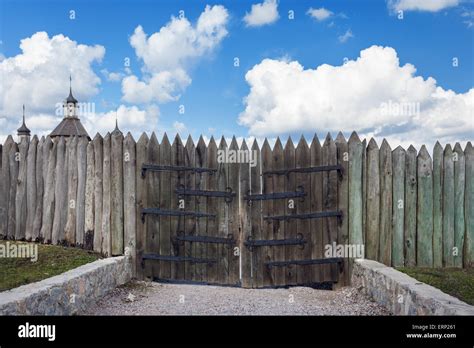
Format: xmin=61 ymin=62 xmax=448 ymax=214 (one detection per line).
xmin=0 ymin=0 xmax=474 ymax=147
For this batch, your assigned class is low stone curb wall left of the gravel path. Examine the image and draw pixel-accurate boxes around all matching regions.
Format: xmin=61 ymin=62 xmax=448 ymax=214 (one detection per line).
xmin=0 ymin=256 xmax=132 ymax=315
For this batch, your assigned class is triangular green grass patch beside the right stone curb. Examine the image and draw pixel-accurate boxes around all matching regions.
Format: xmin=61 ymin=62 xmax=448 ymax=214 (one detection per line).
xmin=397 ymin=267 xmax=474 ymax=305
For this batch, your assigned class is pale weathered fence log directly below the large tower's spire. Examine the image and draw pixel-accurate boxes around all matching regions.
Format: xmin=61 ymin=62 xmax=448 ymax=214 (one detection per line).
xmin=61 ymin=137 xmax=78 ymax=245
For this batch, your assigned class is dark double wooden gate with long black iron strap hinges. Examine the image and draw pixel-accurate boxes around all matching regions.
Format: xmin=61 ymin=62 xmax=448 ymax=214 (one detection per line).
xmin=137 ymin=135 xmax=347 ymax=287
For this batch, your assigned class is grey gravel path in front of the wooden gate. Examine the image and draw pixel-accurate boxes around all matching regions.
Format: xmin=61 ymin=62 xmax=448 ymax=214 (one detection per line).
xmin=85 ymin=281 xmax=389 ymax=315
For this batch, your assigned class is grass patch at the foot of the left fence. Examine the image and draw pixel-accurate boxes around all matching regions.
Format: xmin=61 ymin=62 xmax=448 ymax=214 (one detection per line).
xmin=0 ymin=241 xmax=100 ymax=291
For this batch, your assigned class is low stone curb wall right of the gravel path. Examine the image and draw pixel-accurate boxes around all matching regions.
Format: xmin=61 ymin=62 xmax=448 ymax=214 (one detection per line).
xmin=352 ymin=259 xmax=474 ymax=315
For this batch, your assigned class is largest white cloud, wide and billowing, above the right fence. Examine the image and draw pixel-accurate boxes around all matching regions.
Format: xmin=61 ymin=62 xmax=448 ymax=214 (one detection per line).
xmin=239 ymin=46 xmax=474 ymax=144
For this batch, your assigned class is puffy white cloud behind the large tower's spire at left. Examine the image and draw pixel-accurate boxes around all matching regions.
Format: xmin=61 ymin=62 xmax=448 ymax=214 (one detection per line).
xmin=0 ymin=32 xmax=105 ymax=139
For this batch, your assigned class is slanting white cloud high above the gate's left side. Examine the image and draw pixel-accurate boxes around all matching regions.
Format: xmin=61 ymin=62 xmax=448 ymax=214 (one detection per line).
xmin=122 ymin=5 xmax=229 ymax=103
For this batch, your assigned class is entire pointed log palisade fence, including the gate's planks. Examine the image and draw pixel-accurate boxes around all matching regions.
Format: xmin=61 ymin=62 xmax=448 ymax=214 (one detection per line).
xmin=0 ymin=131 xmax=474 ymax=287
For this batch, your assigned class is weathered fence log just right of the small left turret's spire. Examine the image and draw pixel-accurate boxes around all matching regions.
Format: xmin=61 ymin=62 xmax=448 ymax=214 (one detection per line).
xmin=25 ymin=135 xmax=38 ymax=241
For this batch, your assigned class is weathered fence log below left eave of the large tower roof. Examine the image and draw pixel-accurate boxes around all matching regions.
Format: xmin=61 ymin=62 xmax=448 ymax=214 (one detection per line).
xmin=51 ymin=137 xmax=67 ymax=244
